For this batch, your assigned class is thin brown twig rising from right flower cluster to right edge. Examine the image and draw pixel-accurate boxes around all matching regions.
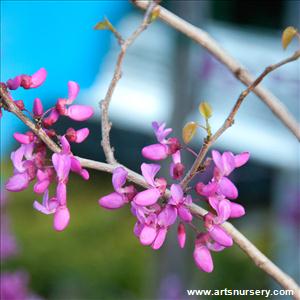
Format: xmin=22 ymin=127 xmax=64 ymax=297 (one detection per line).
xmin=181 ymin=51 xmax=300 ymax=188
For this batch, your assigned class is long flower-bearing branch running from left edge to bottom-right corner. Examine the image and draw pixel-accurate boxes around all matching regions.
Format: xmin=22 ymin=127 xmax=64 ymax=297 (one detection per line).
xmin=0 ymin=88 xmax=300 ymax=299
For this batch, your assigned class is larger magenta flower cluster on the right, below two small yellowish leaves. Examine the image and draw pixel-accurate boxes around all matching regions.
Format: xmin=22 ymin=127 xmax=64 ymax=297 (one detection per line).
xmin=99 ymin=122 xmax=249 ymax=272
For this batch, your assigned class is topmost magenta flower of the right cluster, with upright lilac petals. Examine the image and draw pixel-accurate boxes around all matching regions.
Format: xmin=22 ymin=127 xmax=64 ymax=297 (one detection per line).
xmin=142 ymin=122 xmax=181 ymax=160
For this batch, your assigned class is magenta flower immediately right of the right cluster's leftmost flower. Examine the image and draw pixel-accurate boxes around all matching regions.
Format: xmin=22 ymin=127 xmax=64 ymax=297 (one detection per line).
xmin=133 ymin=163 xmax=167 ymax=206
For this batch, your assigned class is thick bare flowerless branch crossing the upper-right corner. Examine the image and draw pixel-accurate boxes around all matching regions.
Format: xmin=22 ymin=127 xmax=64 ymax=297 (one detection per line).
xmin=133 ymin=0 xmax=300 ymax=140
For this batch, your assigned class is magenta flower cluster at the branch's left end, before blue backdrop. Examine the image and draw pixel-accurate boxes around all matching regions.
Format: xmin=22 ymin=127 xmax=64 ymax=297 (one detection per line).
xmin=1 ymin=68 xmax=93 ymax=231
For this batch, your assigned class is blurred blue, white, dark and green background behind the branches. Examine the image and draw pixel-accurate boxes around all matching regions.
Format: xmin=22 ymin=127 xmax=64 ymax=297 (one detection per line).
xmin=1 ymin=0 xmax=300 ymax=300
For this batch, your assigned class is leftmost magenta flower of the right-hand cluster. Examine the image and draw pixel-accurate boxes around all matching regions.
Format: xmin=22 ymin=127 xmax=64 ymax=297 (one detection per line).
xmin=98 ymin=167 xmax=136 ymax=209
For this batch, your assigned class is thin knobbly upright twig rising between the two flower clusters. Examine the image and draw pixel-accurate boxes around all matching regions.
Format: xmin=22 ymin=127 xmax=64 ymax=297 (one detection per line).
xmin=100 ymin=1 xmax=157 ymax=164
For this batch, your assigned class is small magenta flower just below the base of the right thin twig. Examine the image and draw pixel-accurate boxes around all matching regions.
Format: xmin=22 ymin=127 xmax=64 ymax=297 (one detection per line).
xmin=168 ymin=184 xmax=193 ymax=222
